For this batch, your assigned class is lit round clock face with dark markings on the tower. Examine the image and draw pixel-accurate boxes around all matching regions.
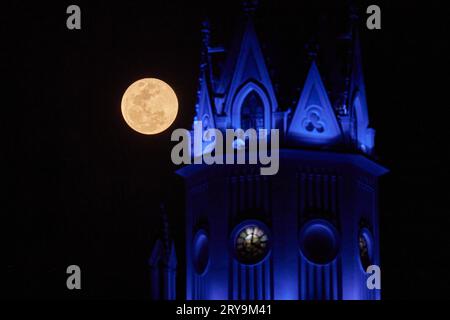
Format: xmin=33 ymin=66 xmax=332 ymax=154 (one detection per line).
xmin=234 ymin=224 xmax=269 ymax=264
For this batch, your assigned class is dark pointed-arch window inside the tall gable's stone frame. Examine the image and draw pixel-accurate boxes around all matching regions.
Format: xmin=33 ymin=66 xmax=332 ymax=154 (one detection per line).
xmin=241 ymin=90 xmax=264 ymax=130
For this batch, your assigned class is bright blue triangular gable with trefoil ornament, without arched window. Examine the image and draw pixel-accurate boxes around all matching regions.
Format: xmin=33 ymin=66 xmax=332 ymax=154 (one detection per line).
xmin=288 ymin=62 xmax=341 ymax=146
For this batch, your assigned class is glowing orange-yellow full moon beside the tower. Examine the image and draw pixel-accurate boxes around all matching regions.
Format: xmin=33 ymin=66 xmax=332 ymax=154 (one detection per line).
xmin=121 ymin=78 xmax=178 ymax=134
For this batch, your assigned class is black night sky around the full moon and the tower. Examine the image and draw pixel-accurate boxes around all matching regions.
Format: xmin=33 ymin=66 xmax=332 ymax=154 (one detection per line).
xmin=0 ymin=0 xmax=450 ymax=299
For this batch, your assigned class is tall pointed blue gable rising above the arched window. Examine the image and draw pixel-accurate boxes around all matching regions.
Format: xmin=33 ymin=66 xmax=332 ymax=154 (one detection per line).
xmin=218 ymin=19 xmax=278 ymax=118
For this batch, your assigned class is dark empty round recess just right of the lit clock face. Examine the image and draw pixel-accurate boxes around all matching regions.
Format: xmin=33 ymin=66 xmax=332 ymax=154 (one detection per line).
xmin=300 ymin=219 xmax=339 ymax=265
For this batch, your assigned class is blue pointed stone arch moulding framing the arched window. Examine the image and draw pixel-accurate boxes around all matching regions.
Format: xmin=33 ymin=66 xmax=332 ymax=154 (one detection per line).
xmin=231 ymin=81 xmax=271 ymax=130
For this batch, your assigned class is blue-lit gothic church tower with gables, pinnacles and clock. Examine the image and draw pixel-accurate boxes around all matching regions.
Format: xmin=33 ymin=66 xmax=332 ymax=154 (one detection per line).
xmin=169 ymin=2 xmax=386 ymax=300
